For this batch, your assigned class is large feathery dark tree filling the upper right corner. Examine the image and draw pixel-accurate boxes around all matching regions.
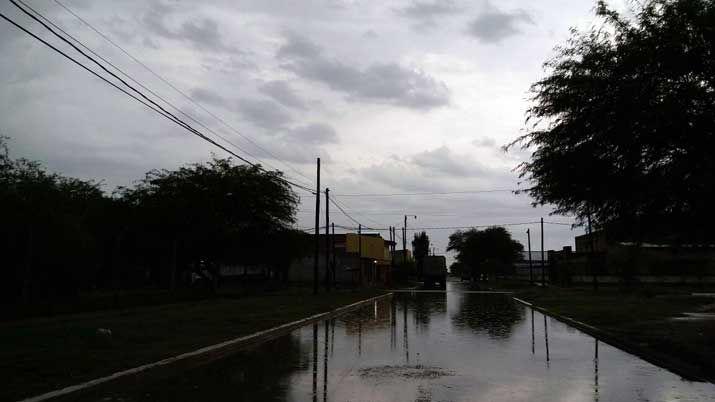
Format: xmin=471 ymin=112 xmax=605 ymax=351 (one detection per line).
xmin=510 ymin=0 xmax=715 ymax=243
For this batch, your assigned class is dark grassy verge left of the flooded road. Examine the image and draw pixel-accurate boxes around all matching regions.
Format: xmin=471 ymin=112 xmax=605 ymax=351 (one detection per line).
xmin=0 ymin=288 xmax=380 ymax=400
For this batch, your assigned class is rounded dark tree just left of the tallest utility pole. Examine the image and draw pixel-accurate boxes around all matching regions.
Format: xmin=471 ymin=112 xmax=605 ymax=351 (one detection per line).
xmin=119 ymin=158 xmax=298 ymax=288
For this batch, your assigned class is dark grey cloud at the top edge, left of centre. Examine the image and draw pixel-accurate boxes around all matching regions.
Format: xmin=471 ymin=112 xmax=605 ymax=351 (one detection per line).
xmin=142 ymin=2 xmax=240 ymax=53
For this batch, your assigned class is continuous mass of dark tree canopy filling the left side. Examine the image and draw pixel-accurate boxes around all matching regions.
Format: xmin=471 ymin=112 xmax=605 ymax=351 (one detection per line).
xmin=0 ymin=137 xmax=309 ymax=301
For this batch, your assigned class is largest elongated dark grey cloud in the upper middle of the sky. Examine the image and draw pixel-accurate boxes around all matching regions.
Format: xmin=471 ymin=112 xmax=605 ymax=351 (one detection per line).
xmin=278 ymin=35 xmax=449 ymax=110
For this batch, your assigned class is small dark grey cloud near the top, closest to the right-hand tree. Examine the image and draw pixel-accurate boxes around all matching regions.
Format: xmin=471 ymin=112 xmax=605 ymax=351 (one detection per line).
xmin=468 ymin=6 xmax=534 ymax=43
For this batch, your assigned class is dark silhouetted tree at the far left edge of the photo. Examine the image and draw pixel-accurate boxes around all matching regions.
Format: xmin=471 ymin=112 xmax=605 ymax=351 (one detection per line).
xmin=0 ymin=137 xmax=109 ymax=302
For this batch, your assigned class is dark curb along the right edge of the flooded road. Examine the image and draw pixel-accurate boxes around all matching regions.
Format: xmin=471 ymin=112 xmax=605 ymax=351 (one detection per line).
xmin=512 ymin=296 xmax=713 ymax=382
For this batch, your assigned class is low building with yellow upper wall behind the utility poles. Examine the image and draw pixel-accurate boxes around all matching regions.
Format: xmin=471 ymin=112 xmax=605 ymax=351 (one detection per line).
xmin=289 ymin=233 xmax=394 ymax=286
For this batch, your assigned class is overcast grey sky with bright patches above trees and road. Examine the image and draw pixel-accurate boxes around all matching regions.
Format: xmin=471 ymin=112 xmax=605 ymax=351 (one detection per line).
xmin=0 ymin=0 xmax=632 ymax=260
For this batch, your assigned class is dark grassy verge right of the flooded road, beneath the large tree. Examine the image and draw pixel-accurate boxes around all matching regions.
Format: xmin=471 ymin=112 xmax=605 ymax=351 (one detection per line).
xmin=504 ymin=287 xmax=715 ymax=381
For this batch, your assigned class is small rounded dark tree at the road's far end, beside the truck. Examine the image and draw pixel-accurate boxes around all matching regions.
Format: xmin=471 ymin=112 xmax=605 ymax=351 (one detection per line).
xmin=447 ymin=226 xmax=524 ymax=279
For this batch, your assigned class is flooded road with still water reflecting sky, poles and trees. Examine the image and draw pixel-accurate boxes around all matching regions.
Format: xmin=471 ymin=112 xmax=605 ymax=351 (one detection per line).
xmin=87 ymin=283 xmax=715 ymax=402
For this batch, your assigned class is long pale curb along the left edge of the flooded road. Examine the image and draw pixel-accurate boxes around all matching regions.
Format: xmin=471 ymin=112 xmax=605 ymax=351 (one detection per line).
xmin=20 ymin=293 xmax=392 ymax=402
